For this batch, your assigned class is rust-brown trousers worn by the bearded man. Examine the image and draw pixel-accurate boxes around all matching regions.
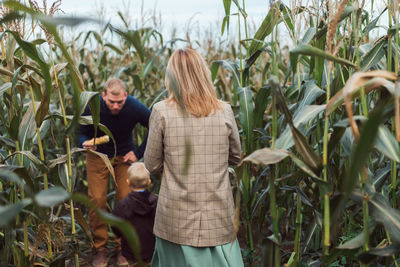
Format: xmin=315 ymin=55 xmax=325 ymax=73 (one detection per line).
xmin=86 ymin=152 xmax=130 ymax=251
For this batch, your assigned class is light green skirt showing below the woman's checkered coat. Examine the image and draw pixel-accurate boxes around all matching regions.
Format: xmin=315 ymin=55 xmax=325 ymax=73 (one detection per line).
xmin=151 ymin=237 xmax=244 ymax=267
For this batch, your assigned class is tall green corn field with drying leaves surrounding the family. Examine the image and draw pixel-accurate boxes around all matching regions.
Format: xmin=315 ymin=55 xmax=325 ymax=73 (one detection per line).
xmin=0 ymin=0 xmax=400 ymax=267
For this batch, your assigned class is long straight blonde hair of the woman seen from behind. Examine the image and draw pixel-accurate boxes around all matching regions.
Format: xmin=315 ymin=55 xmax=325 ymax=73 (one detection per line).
xmin=165 ymin=48 xmax=222 ymax=117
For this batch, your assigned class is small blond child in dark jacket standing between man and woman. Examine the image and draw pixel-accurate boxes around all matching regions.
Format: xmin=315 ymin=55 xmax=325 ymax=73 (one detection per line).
xmin=113 ymin=162 xmax=157 ymax=262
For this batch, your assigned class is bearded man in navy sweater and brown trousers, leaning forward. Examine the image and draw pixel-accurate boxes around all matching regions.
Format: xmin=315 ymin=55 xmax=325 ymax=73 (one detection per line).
xmin=79 ymin=78 xmax=150 ymax=267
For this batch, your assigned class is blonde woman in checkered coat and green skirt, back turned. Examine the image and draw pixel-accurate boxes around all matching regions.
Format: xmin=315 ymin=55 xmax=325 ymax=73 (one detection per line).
xmin=144 ymin=48 xmax=243 ymax=267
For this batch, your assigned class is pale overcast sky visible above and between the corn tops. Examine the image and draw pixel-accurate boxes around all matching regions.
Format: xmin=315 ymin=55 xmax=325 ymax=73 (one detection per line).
xmin=37 ymin=0 xmax=387 ymax=46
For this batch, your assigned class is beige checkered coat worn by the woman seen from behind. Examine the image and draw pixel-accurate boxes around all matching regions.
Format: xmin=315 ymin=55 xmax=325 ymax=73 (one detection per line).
xmin=144 ymin=100 xmax=241 ymax=247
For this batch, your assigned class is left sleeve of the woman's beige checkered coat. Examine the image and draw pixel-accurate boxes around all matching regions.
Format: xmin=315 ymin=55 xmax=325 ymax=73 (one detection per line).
xmin=144 ymin=104 xmax=165 ymax=173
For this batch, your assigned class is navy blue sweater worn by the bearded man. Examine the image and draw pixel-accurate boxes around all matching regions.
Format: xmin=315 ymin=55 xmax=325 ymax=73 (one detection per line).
xmin=79 ymin=95 xmax=150 ymax=159
